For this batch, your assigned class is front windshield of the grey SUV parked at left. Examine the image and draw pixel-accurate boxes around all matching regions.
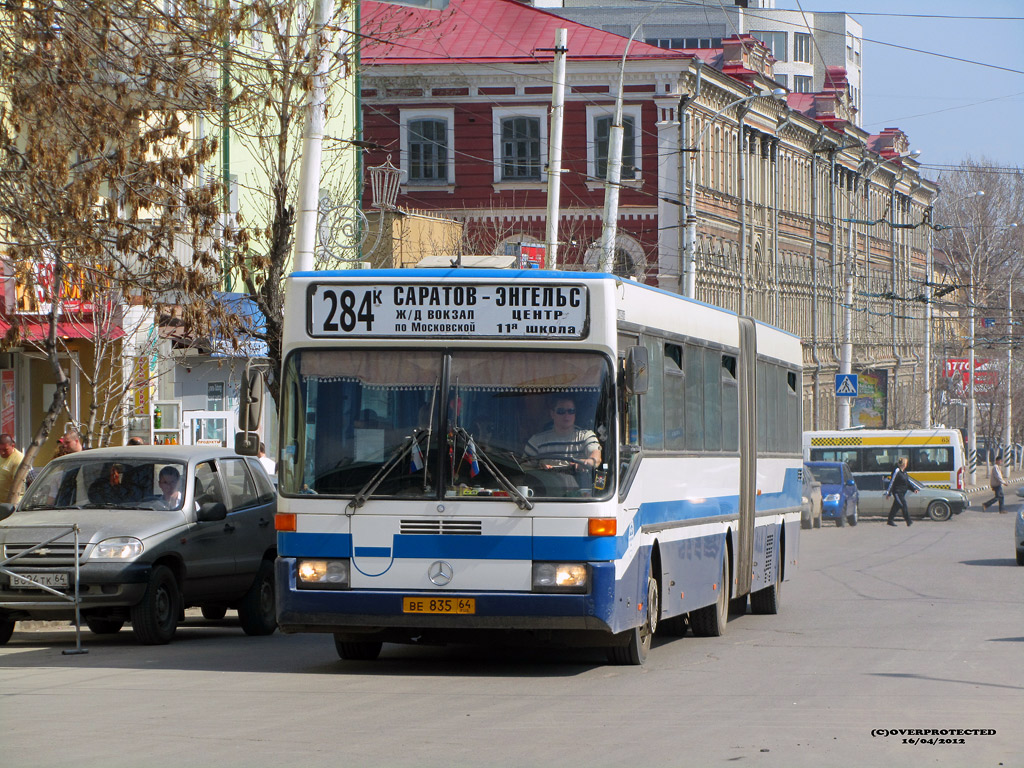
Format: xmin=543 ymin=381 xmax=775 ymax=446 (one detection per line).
xmin=20 ymin=460 xmax=185 ymax=510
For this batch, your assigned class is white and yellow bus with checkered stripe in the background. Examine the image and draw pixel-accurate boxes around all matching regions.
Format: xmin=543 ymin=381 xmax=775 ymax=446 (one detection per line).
xmin=804 ymin=428 xmax=965 ymax=490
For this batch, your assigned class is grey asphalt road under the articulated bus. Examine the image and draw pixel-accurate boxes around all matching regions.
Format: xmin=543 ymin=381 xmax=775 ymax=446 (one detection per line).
xmin=0 ymin=494 xmax=1024 ymax=768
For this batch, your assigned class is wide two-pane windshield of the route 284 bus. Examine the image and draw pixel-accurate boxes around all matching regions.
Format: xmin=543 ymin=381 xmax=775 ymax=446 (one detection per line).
xmin=278 ymin=349 xmax=614 ymax=499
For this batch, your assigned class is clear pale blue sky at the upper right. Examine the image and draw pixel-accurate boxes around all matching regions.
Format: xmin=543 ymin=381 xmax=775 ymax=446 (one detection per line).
xmin=537 ymin=0 xmax=1024 ymax=178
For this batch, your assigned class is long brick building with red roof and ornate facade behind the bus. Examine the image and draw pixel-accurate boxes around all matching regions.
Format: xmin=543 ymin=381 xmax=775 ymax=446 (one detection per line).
xmin=360 ymin=0 xmax=935 ymax=428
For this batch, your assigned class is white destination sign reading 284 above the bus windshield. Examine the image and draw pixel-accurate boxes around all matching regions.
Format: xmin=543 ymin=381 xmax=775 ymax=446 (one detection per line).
xmin=307 ymin=281 xmax=589 ymax=339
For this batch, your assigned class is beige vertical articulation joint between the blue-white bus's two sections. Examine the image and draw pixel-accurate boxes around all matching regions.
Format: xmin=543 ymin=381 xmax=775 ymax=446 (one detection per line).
xmin=732 ymin=317 xmax=758 ymax=595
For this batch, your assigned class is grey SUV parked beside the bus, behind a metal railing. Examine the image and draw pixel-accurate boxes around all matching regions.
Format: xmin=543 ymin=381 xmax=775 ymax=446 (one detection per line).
xmin=0 ymin=445 xmax=276 ymax=645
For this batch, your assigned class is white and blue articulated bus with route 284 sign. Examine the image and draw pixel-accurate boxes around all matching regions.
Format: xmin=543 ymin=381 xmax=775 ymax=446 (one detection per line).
xmin=275 ymin=269 xmax=802 ymax=664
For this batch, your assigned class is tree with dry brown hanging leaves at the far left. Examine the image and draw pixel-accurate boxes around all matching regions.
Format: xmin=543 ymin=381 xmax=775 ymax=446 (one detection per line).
xmin=0 ymin=0 xmax=241 ymax=499
